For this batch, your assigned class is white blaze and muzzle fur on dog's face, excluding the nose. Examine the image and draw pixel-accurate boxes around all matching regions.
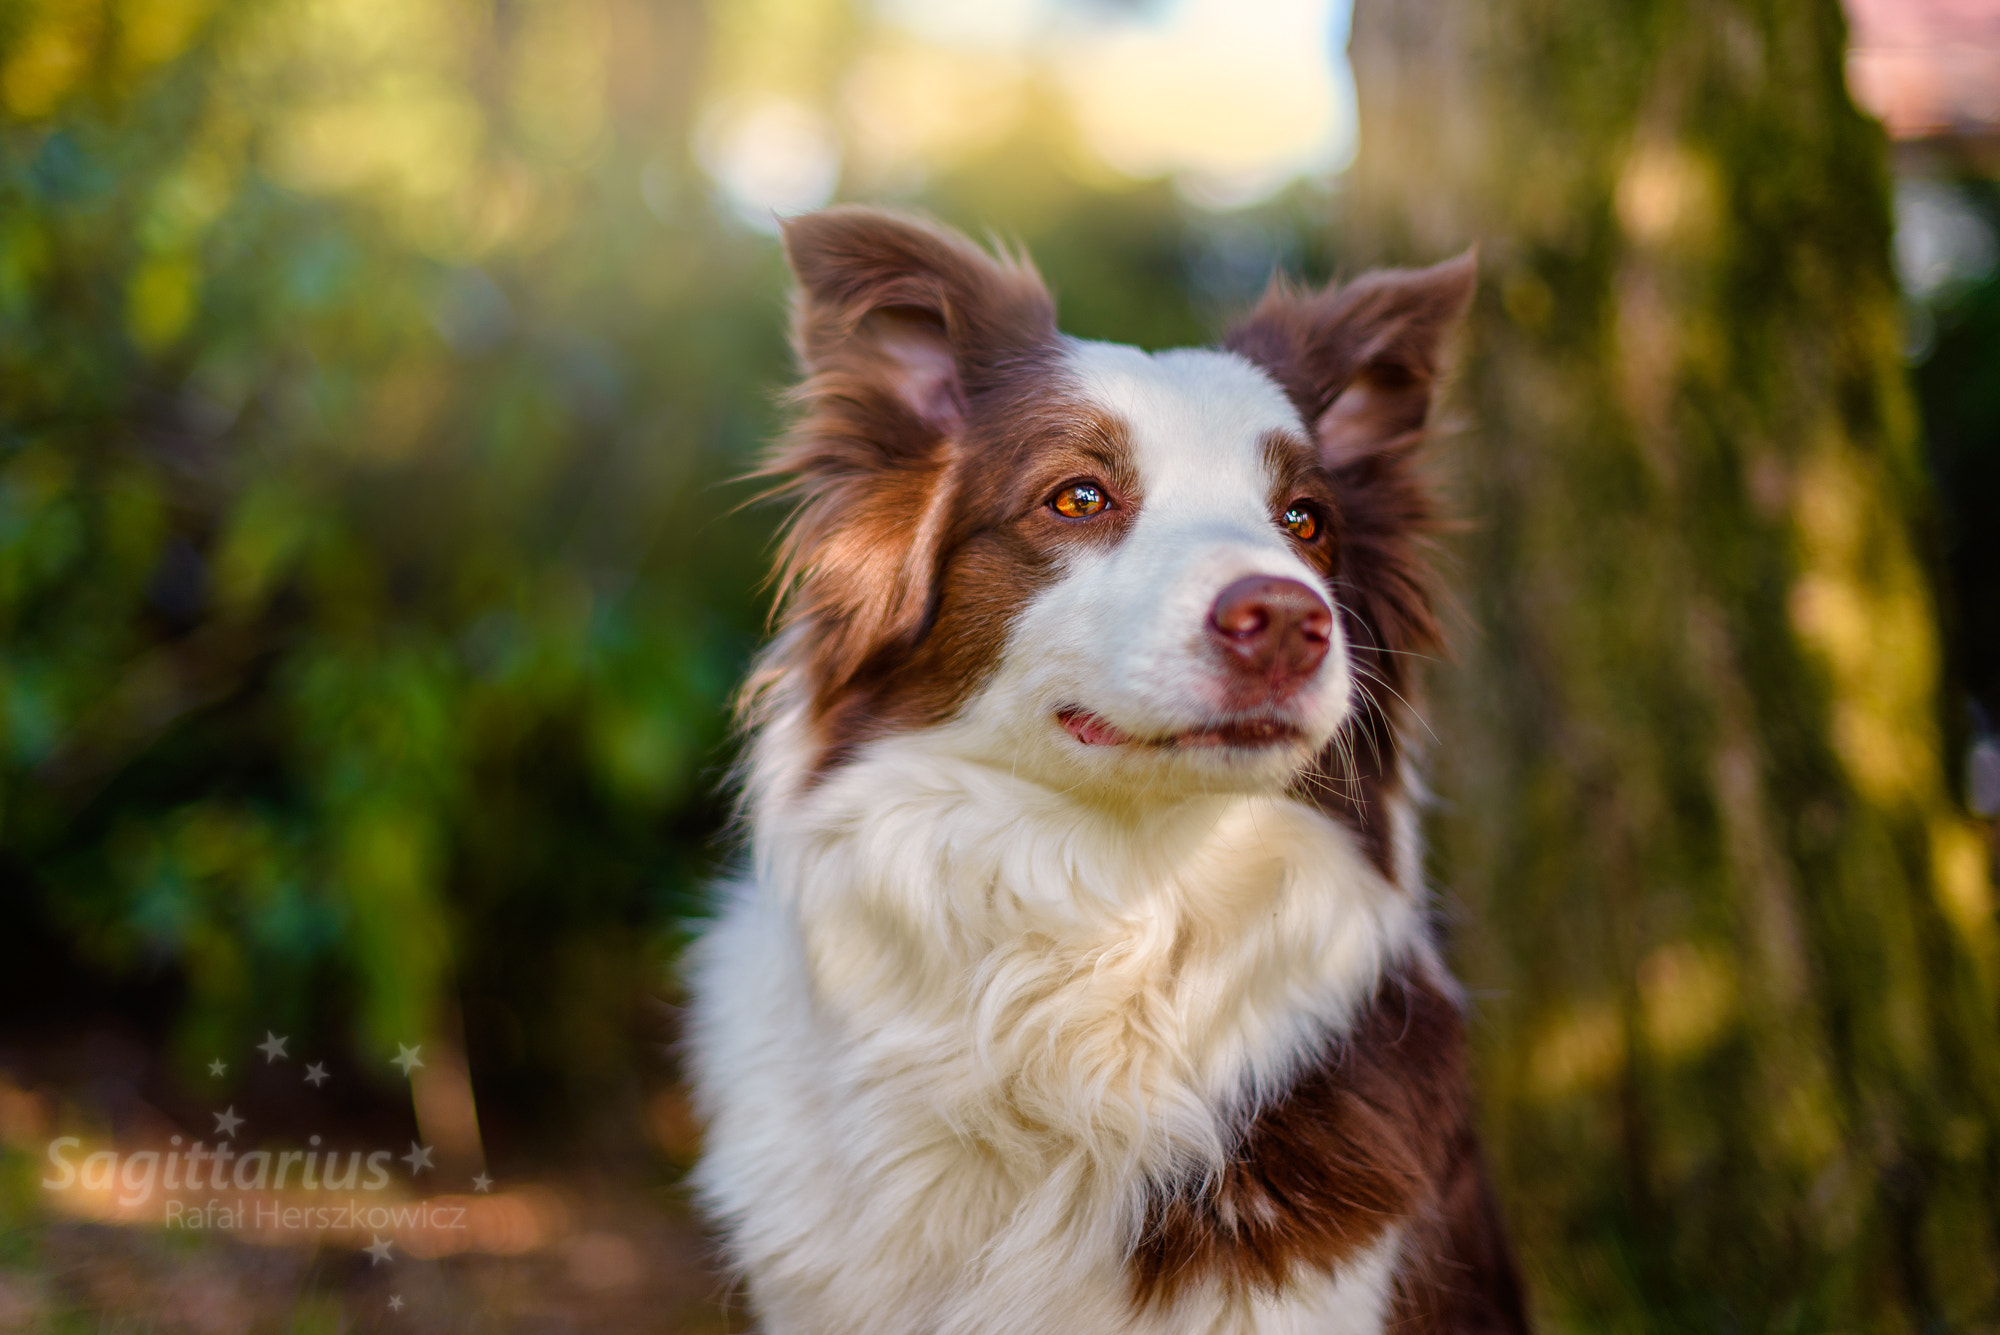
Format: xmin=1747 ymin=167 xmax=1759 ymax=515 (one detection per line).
xmin=962 ymin=342 xmax=1352 ymax=795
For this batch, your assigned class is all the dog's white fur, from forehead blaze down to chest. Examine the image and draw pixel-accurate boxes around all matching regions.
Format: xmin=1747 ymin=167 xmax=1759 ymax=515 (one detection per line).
xmin=692 ymin=344 xmax=1428 ymax=1335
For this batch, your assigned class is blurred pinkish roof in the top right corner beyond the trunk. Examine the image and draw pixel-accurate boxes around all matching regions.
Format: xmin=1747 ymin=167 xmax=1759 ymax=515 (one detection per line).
xmin=1846 ymin=0 xmax=2000 ymax=142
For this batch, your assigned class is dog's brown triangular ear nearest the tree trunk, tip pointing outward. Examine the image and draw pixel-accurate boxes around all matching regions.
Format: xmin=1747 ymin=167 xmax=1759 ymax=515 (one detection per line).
xmin=1224 ymin=250 xmax=1478 ymax=470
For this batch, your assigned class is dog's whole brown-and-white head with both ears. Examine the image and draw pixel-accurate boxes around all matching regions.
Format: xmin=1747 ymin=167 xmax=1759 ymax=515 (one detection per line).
xmin=752 ymin=208 xmax=1472 ymax=855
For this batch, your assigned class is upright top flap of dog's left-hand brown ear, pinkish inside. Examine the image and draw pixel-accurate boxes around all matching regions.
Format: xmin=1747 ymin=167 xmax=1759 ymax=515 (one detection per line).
xmin=784 ymin=208 xmax=1056 ymax=436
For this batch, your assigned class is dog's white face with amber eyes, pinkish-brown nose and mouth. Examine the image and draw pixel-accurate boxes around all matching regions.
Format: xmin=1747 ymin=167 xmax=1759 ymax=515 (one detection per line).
xmin=970 ymin=342 xmax=1352 ymax=789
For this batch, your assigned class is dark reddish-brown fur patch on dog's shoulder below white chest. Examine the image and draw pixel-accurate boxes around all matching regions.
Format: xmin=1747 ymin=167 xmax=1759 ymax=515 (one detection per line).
xmin=1130 ymin=969 xmax=1526 ymax=1335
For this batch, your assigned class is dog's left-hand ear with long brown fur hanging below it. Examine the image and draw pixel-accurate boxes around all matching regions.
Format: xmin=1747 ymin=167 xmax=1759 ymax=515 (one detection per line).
xmin=760 ymin=208 xmax=1056 ymax=711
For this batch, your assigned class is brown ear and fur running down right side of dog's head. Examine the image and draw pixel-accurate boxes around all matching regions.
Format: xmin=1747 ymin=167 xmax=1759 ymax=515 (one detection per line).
xmin=1224 ymin=252 xmax=1476 ymax=873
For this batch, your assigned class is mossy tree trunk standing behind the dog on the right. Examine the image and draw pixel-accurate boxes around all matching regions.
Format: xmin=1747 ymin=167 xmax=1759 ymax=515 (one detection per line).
xmin=1348 ymin=0 xmax=2000 ymax=1331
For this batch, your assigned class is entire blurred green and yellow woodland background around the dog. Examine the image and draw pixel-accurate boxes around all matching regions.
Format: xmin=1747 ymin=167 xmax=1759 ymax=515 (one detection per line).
xmin=0 ymin=0 xmax=2000 ymax=1331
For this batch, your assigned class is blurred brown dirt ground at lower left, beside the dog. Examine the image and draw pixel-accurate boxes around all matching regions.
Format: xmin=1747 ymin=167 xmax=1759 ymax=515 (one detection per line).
xmin=0 ymin=1035 xmax=750 ymax=1335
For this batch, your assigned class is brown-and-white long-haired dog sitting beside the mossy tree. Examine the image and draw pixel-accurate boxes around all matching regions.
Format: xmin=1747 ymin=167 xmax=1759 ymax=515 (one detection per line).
xmin=688 ymin=208 xmax=1526 ymax=1335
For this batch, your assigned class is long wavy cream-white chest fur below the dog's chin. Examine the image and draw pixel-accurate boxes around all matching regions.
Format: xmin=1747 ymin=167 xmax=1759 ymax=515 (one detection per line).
xmin=696 ymin=715 xmax=1430 ymax=1335
